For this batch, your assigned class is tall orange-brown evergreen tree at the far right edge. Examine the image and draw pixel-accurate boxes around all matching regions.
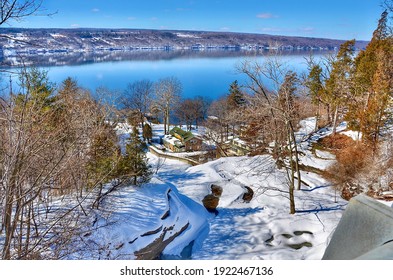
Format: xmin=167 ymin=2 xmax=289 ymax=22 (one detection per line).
xmin=347 ymin=8 xmax=393 ymax=148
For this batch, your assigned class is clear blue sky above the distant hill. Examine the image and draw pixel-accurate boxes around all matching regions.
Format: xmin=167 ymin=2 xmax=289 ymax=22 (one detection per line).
xmin=12 ymin=0 xmax=383 ymax=40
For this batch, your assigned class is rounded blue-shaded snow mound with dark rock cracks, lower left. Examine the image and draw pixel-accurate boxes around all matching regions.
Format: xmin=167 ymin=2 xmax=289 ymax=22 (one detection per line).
xmin=76 ymin=178 xmax=209 ymax=259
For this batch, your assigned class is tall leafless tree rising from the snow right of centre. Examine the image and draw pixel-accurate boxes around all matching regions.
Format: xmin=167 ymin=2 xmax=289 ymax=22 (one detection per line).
xmin=238 ymin=57 xmax=301 ymax=214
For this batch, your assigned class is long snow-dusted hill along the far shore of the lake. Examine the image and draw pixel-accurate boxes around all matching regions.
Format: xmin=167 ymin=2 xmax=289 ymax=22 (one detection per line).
xmin=0 ymin=28 xmax=368 ymax=66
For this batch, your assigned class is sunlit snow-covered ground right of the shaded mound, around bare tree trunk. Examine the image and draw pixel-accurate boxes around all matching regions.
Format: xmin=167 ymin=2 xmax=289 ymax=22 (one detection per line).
xmin=151 ymin=153 xmax=346 ymax=259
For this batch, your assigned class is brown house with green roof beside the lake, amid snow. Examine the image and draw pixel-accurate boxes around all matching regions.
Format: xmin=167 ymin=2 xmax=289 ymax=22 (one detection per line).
xmin=162 ymin=127 xmax=202 ymax=153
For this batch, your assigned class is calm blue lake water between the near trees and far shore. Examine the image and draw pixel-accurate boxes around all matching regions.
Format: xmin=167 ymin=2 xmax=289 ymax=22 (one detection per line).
xmin=1 ymin=52 xmax=330 ymax=99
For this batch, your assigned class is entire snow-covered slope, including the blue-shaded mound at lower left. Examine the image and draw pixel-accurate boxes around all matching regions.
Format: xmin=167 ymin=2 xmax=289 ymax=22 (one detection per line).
xmin=76 ymin=116 xmax=347 ymax=260
